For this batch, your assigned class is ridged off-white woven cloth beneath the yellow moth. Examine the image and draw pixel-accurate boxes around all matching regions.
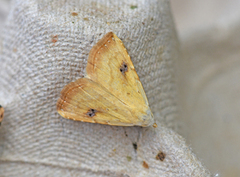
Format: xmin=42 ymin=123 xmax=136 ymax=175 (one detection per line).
xmin=0 ymin=0 xmax=210 ymax=177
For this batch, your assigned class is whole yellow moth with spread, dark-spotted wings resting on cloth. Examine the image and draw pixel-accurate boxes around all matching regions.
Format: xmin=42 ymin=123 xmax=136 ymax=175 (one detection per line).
xmin=57 ymin=32 xmax=154 ymax=127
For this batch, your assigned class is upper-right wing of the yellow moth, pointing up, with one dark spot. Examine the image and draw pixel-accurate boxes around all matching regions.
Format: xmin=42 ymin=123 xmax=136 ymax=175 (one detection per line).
xmin=86 ymin=32 xmax=153 ymax=119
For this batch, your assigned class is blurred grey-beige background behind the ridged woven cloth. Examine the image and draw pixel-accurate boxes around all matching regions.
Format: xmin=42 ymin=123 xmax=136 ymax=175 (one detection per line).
xmin=0 ymin=0 xmax=240 ymax=177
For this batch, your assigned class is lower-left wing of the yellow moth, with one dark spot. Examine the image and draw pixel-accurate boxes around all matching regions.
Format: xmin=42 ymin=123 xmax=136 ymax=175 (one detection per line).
xmin=57 ymin=78 xmax=151 ymax=126
